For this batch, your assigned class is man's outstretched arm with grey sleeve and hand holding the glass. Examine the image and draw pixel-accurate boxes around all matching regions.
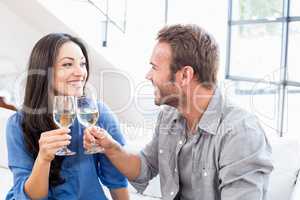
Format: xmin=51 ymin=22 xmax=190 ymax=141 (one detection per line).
xmin=83 ymin=109 xmax=162 ymax=192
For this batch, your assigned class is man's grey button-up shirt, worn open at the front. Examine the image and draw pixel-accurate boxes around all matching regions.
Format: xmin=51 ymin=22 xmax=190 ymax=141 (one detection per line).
xmin=131 ymin=89 xmax=273 ymax=200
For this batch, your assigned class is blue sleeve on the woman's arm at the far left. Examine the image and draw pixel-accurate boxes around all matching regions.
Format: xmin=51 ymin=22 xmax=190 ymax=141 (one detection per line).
xmin=6 ymin=114 xmax=34 ymax=200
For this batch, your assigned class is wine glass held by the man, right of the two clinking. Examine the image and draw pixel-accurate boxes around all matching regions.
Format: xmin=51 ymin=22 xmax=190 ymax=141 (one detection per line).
xmin=77 ymin=95 xmax=104 ymax=154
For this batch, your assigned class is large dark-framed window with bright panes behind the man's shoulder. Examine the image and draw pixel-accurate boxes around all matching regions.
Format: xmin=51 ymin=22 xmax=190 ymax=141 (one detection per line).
xmin=225 ymin=0 xmax=300 ymax=136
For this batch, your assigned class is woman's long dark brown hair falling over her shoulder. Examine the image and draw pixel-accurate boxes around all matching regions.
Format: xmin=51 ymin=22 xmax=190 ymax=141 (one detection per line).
xmin=22 ymin=33 xmax=89 ymax=186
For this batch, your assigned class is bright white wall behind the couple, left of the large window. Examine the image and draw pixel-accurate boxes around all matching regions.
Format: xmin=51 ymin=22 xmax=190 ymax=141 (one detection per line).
xmin=0 ymin=0 xmax=227 ymax=125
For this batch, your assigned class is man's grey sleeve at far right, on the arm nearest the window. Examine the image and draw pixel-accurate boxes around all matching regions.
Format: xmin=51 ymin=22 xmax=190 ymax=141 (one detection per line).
xmin=219 ymin=117 xmax=273 ymax=200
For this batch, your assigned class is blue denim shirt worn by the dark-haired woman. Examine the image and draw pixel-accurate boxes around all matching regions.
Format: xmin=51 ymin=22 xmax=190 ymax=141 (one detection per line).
xmin=6 ymin=103 xmax=127 ymax=200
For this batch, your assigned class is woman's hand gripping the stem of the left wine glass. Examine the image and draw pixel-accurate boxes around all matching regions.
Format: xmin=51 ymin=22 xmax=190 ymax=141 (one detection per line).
xmin=38 ymin=128 xmax=71 ymax=162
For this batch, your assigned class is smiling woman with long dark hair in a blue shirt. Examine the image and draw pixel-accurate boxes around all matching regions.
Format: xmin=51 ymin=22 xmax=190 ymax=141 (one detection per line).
xmin=6 ymin=33 xmax=129 ymax=200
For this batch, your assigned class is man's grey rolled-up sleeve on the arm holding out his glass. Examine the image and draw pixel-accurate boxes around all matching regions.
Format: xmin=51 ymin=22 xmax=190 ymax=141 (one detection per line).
xmin=130 ymin=112 xmax=162 ymax=193
